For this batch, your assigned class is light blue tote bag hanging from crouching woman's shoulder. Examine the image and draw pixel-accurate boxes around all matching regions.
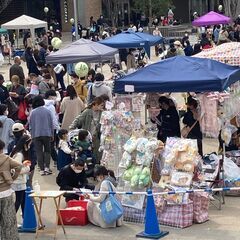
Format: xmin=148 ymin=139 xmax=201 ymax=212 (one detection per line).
xmin=100 ymin=181 xmax=123 ymax=224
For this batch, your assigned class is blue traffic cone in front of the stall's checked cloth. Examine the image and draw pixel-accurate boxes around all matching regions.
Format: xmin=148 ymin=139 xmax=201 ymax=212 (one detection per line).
xmin=136 ymin=189 xmax=169 ymax=239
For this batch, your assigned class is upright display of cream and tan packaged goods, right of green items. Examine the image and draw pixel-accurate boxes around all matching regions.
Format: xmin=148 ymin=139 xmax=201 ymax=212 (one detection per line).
xmin=159 ymin=138 xmax=200 ymax=204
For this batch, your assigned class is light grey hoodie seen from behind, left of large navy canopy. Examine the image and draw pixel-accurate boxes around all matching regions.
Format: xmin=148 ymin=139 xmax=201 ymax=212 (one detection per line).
xmin=87 ymin=81 xmax=112 ymax=104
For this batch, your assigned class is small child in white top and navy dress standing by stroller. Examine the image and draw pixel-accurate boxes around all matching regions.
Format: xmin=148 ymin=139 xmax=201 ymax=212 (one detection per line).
xmin=57 ymin=129 xmax=73 ymax=171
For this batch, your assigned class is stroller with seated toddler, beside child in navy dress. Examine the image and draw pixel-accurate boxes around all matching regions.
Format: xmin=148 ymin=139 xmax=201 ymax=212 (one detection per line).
xmin=68 ymin=129 xmax=96 ymax=178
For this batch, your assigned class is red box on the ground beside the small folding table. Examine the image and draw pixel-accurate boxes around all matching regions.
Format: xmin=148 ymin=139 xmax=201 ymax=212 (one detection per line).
xmin=58 ymin=200 xmax=88 ymax=226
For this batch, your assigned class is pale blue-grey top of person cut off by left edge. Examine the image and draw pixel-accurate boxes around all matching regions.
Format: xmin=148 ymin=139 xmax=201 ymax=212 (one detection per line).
xmin=0 ymin=115 xmax=14 ymax=153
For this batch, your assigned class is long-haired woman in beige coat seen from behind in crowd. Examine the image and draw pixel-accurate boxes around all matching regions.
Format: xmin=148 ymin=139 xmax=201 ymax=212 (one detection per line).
xmin=60 ymin=85 xmax=85 ymax=130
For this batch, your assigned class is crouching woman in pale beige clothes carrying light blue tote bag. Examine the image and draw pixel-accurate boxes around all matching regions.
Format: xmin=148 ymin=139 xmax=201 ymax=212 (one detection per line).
xmin=85 ymin=166 xmax=123 ymax=228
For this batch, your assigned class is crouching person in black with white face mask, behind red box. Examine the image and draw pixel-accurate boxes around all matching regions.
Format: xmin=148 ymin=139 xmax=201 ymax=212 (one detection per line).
xmin=56 ymin=158 xmax=94 ymax=202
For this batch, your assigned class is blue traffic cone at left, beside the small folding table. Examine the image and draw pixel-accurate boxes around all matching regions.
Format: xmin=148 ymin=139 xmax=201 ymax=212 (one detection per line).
xmin=18 ymin=187 xmax=37 ymax=233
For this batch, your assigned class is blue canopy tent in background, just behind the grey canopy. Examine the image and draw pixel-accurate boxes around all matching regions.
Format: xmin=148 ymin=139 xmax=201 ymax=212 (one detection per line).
xmin=100 ymin=31 xmax=163 ymax=57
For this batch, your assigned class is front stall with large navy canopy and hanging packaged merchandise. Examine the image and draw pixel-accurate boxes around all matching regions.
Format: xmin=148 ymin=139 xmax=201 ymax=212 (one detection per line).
xmin=94 ymin=57 xmax=240 ymax=228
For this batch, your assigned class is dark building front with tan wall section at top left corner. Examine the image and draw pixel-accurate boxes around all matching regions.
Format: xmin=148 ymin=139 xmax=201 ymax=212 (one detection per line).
xmin=0 ymin=0 xmax=102 ymax=31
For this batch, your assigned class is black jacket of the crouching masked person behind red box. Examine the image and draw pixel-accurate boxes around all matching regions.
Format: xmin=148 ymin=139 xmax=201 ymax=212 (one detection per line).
xmin=56 ymin=164 xmax=88 ymax=191
